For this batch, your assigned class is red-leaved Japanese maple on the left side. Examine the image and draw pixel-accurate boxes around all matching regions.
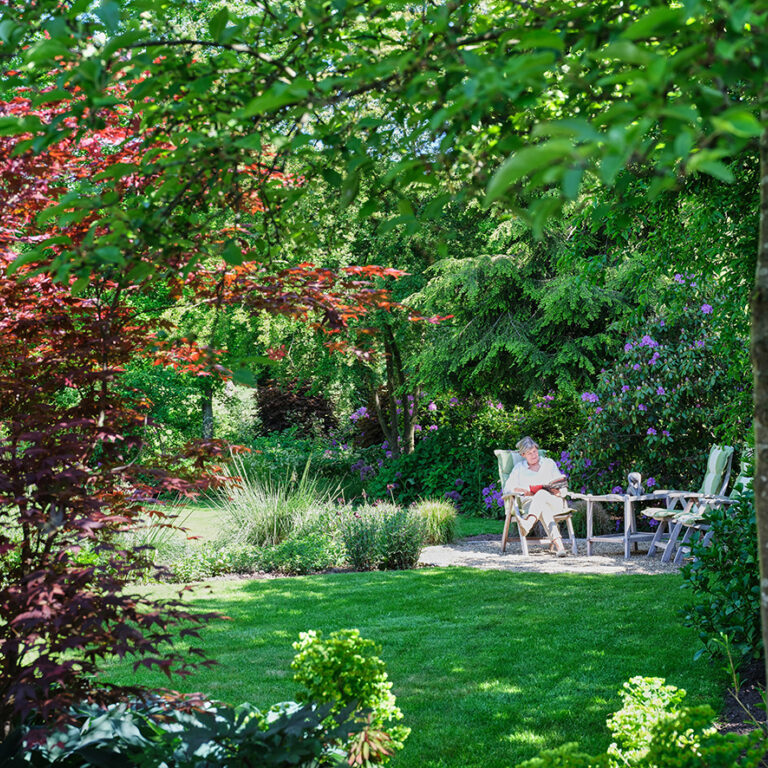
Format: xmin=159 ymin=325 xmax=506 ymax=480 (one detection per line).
xmin=0 ymin=85 xmax=404 ymax=728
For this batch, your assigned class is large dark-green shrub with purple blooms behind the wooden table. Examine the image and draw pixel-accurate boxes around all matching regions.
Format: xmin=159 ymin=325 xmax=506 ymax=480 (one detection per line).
xmin=563 ymin=275 xmax=751 ymax=492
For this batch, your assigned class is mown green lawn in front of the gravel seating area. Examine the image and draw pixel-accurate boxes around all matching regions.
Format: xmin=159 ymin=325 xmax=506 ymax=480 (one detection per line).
xmin=100 ymin=568 xmax=722 ymax=768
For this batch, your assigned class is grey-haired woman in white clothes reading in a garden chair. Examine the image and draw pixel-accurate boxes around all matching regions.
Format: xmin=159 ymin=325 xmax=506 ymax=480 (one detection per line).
xmin=504 ymin=437 xmax=568 ymax=557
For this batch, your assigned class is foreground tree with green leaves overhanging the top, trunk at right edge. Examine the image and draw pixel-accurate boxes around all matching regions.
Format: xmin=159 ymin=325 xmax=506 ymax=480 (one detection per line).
xmin=0 ymin=0 xmax=768 ymax=704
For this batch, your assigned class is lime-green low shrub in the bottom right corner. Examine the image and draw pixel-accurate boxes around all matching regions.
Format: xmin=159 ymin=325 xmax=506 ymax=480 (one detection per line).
xmin=518 ymin=677 xmax=768 ymax=768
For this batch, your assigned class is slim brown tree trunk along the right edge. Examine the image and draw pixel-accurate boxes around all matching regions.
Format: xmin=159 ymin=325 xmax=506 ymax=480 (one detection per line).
xmin=751 ymin=118 xmax=768 ymax=674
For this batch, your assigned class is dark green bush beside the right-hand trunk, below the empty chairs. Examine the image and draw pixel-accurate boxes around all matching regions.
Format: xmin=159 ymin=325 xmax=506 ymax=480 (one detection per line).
xmin=683 ymin=488 xmax=763 ymax=667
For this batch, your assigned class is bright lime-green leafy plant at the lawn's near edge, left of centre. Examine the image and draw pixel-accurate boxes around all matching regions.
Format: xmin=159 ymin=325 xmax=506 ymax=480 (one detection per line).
xmin=291 ymin=629 xmax=411 ymax=750
